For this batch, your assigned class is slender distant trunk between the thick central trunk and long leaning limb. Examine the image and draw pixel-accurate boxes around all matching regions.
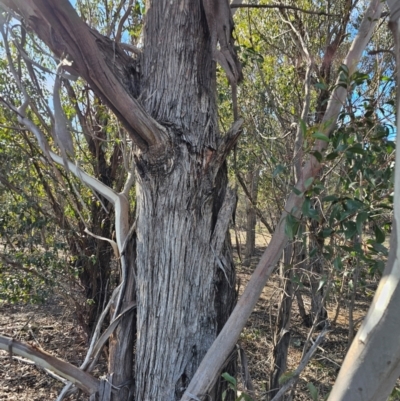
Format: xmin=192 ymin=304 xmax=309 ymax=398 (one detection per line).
xmin=243 ymin=169 xmax=260 ymax=266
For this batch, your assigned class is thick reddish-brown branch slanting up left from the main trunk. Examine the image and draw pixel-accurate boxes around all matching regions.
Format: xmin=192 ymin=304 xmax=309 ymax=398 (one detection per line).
xmin=0 ymin=0 xmax=167 ymax=151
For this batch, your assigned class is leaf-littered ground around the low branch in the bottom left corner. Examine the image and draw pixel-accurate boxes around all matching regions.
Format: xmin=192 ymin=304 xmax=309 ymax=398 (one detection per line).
xmin=0 ymin=297 xmax=91 ymax=401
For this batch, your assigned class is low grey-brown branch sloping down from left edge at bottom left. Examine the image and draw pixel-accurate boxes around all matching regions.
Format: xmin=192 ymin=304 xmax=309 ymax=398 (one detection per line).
xmin=0 ymin=335 xmax=100 ymax=395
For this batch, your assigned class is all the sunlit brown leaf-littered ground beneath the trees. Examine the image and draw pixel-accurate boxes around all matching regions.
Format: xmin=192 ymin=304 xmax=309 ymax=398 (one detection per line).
xmin=0 ymin=231 xmax=378 ymax=401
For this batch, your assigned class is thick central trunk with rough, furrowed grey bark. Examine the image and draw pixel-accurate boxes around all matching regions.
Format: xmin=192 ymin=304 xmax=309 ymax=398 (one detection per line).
xmin=131 ymin=0 xmax=235 ymax=401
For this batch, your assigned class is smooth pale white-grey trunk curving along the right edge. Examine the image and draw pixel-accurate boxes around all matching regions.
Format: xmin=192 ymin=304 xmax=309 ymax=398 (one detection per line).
xmin=329 ymin=0 xmax=400 ymax=401
